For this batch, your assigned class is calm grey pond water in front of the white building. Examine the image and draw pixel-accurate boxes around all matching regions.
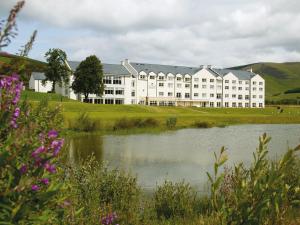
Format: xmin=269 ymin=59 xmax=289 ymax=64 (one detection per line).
xmin=68 ymin=124 xmax=300 ymax=190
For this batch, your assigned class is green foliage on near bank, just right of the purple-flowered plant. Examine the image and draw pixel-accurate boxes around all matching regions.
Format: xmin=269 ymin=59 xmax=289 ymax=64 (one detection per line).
xmin=66 ymin=157 xmax=140 ymax=224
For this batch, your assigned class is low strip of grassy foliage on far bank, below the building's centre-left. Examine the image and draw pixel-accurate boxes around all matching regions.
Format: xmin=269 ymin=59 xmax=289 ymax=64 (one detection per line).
xmin=113 ymin=117 xmax=159 ymax=130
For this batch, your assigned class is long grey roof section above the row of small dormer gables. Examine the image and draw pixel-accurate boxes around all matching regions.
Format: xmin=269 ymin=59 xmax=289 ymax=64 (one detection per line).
xmin=130 ymin=62 xmax=200 ymax=75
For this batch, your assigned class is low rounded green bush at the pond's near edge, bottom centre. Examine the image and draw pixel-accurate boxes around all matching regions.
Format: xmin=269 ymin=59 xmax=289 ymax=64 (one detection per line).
xmin=154 ymin=181 xmax=196 ymax=219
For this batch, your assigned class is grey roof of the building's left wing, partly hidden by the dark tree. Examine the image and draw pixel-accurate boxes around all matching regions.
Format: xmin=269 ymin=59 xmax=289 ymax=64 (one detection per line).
xmin=68 ymin=61 xmax=130 ymax=75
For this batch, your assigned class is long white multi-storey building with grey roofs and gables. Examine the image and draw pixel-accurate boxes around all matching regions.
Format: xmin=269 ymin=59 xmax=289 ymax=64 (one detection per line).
xmin=30 ymin=60 xmax=265 ymax=108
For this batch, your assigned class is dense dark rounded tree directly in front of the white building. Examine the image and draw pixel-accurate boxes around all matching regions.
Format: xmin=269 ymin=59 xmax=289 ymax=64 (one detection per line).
xmin=72 ymin=55 xmax=104 ymax=101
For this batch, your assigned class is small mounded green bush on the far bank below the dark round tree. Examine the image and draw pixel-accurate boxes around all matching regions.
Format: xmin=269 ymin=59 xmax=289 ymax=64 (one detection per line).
xmin=70 ymin=112 xmax=97 ymax=132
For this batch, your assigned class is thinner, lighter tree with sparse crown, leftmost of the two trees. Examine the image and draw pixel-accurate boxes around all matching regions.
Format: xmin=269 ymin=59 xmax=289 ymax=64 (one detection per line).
xmin=43 ymin=48 xmax=70 ymax=92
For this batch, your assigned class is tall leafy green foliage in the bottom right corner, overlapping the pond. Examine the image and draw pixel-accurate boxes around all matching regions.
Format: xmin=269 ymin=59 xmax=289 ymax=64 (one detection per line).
xmin=208 ymin=134 xmax=300 ymax=224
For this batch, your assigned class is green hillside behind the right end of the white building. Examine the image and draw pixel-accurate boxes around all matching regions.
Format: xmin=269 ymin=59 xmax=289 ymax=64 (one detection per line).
xmin=227 ymin=62 xmax=300 ymax=101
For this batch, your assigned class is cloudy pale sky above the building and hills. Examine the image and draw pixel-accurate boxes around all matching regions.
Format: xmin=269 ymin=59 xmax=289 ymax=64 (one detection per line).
xmin=0 ymin=0 xmax=300 ymax=67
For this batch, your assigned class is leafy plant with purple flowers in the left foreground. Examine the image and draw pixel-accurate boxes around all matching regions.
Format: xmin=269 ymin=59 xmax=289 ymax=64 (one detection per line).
xmin=0 ymin=74 xmax=64 ymax=224
